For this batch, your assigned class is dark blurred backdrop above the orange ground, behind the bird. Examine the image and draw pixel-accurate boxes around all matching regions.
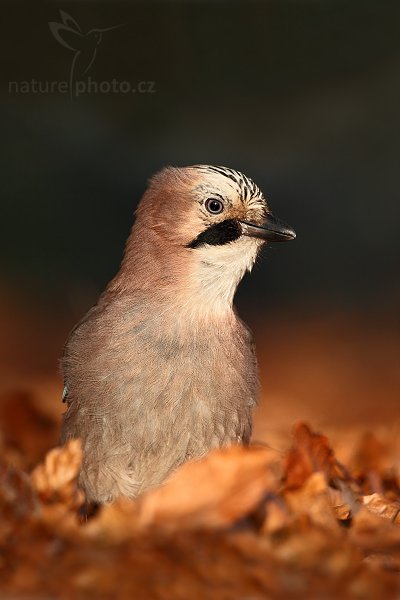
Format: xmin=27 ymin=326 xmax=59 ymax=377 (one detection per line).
xmin=0 ymin=0 xmax=400 ymax=432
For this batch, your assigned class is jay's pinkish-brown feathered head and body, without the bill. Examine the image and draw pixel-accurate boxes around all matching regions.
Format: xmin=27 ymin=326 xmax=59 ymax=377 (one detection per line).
xmin=62 ymin=166 xmax=296 ymax=502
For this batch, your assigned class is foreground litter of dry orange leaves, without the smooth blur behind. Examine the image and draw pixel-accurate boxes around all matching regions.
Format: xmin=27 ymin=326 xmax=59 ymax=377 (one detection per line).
xmin=0 ymin=397 xmax=400 ymax=600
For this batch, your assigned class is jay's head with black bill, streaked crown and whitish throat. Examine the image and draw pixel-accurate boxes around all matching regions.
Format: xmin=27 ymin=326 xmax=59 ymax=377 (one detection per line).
xmin=121 ymin=165 xmax=295 ymax=314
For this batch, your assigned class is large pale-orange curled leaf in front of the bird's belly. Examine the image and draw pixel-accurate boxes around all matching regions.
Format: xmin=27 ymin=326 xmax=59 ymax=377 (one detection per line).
xmin=139 ymin=446 xmax=280 ymax=527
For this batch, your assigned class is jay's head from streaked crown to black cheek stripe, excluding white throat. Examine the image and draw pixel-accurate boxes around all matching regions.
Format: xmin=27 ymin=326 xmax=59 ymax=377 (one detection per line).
xmin=137 ymin=165 xmax=296 ymax=248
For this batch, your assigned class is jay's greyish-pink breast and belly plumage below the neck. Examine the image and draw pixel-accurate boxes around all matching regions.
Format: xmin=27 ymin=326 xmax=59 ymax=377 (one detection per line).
xmin=64 ymin=295 xmax=257 ymax=502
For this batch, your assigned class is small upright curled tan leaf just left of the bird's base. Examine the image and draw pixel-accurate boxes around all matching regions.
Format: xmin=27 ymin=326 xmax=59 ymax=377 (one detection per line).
xmin=31 ymin=440 xmax=84 ymax=508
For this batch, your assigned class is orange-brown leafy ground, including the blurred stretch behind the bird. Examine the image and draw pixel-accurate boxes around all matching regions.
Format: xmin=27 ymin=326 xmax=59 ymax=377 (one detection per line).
xmin=0 ymin=306 xmax=400 ymax=600
